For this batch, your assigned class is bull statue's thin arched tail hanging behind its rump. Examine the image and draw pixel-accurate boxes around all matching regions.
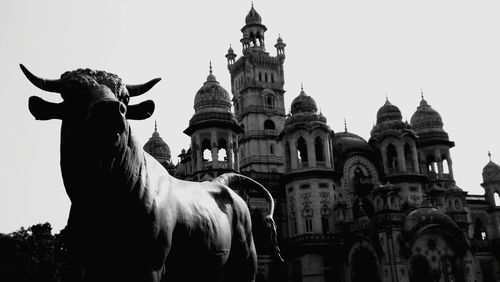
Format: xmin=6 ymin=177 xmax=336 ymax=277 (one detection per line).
xmin=213 ymin=172 xmax=283 ymax=261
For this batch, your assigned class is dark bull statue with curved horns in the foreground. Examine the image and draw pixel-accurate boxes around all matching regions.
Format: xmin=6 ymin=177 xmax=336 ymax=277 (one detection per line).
xmin=20 ymin=65 xmax=281 ymax=281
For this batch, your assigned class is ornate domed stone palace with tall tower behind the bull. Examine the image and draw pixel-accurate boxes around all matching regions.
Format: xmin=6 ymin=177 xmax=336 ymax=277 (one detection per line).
xmin=144 ymin=5 xmax=500 ymax=282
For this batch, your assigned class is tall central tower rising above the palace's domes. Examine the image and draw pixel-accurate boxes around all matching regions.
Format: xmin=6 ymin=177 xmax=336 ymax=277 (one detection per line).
xmin=226 ymin=5 xmax=286 ymax=181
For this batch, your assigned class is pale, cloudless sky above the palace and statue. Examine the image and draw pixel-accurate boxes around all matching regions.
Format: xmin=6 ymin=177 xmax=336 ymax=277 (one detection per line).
xmin=0 ymin=0 xmax=500 ymax=233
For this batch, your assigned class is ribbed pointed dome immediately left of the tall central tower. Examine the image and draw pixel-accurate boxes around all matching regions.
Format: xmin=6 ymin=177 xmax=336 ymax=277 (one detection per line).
xmin=194 ymin=66 xmax=231 ymax=112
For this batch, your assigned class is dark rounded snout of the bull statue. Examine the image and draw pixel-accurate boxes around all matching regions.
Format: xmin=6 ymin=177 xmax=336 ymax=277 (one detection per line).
xmin=89 ymin=101 xmax=127 ymax=137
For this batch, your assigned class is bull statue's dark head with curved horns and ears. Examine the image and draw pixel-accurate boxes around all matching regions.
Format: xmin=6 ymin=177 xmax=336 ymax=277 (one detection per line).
xmin=20 ymin=64 xmax=160 ymax=144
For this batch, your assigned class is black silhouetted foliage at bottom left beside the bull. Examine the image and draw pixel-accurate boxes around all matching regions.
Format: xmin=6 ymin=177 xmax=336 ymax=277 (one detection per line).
xmin=0 ymin=222 xmax=82 ymax=282
